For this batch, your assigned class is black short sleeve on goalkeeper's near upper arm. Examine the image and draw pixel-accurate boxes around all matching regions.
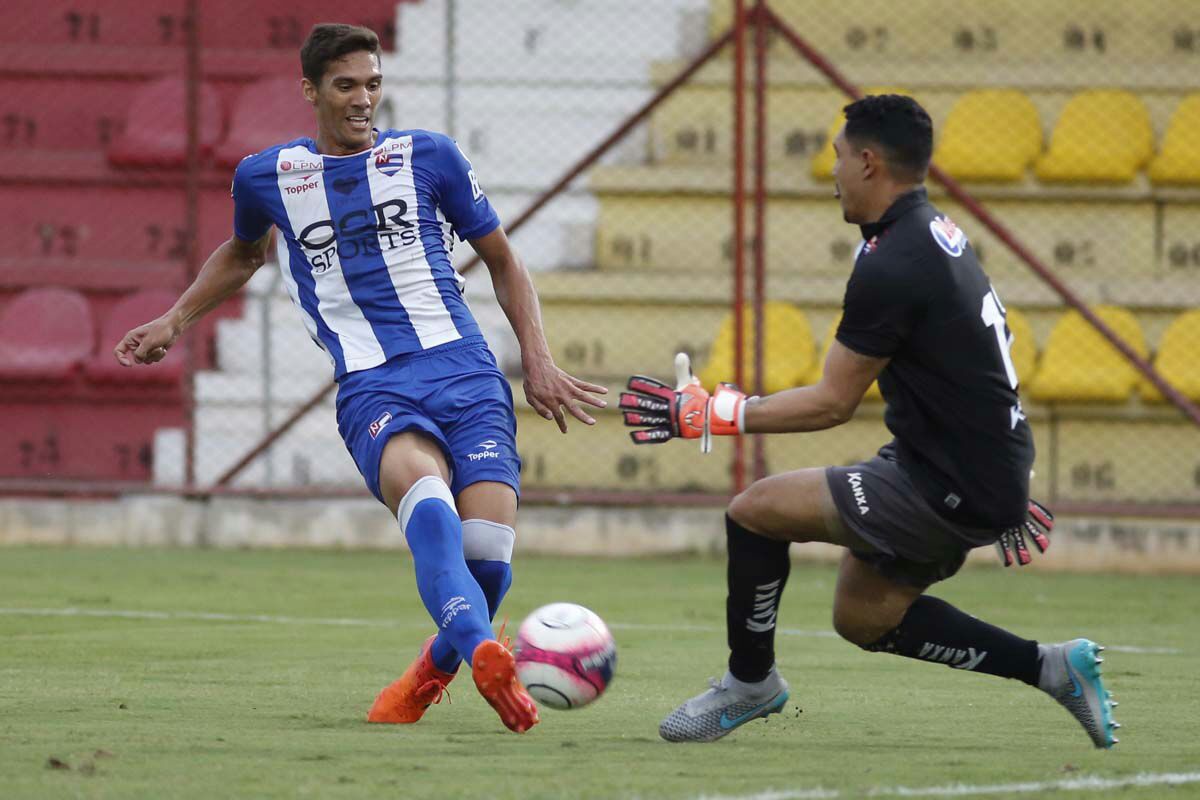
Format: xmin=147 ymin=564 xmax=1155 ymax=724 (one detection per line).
xmin=838 ymin=250 xmax=923 ymax=359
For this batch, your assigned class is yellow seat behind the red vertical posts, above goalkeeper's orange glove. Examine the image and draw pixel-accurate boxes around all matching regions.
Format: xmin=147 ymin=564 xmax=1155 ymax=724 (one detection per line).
xmin=700 ymin=301 xmax=816 ymax=393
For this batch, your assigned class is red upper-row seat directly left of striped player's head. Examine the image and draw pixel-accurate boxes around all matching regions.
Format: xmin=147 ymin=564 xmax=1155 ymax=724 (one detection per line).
xmin=216 ymin=76 xmax=317 ymax=167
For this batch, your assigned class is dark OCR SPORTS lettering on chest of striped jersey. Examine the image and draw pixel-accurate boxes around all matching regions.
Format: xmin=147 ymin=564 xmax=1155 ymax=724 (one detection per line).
xmin=296 ymin=198 xmax=418 ymax=275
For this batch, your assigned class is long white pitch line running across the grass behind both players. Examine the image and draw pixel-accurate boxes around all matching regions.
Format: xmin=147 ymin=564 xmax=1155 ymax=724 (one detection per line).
xmin=0 ymin=608 xmax=1183 ymax=656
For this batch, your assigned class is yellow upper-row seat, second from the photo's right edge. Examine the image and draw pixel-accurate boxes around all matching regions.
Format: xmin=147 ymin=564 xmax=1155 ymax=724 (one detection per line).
xmin=1036 ymin=89 xmax=1154 ymax=182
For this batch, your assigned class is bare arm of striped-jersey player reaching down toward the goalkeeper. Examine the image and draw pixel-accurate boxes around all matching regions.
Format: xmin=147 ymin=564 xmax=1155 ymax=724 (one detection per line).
xmin=470 ymin=228 xmax=608 ymax=433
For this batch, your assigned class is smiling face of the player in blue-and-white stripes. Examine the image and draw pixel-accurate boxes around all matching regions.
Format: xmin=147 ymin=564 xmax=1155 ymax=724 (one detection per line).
xmin=305 ymin=50 xmax=383 ymax=155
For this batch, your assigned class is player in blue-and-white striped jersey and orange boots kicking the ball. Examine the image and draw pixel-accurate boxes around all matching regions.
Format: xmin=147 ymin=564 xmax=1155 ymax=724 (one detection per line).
xmin=114 ymin=24 xmax=607 ymax=733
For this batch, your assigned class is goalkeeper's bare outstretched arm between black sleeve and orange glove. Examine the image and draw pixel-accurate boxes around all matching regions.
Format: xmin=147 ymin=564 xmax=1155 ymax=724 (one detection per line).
xmin=743 ymin=341 xmax=888 ymax=433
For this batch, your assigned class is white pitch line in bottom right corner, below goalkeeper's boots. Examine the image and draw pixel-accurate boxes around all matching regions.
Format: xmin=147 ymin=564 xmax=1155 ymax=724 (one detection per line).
xmin=696 ymin=772 xmax=1200 ymax=800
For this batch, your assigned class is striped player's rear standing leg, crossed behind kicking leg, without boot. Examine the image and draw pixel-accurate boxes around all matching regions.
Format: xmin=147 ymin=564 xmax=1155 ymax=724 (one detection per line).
xmin=431 ymin=481 xmax=517 ymax=673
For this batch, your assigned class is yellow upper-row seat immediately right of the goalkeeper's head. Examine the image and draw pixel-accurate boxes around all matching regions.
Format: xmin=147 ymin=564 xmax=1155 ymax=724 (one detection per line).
xmin=934 ymin=89 xmax=1042 ymax=181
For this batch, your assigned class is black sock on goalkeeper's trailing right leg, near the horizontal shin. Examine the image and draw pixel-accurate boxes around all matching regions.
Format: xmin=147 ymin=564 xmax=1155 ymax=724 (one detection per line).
xmin=863 ymin=595 xmax=1042 ymax=686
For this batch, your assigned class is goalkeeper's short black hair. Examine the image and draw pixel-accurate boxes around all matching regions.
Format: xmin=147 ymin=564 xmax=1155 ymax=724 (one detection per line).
xmin=842 ymin=95 xmax=934 ymax=182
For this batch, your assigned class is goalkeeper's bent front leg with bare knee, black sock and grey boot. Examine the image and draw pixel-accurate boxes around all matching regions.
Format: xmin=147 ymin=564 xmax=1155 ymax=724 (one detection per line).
xmin=659 ymin=469 xmax=860 ymax=741
